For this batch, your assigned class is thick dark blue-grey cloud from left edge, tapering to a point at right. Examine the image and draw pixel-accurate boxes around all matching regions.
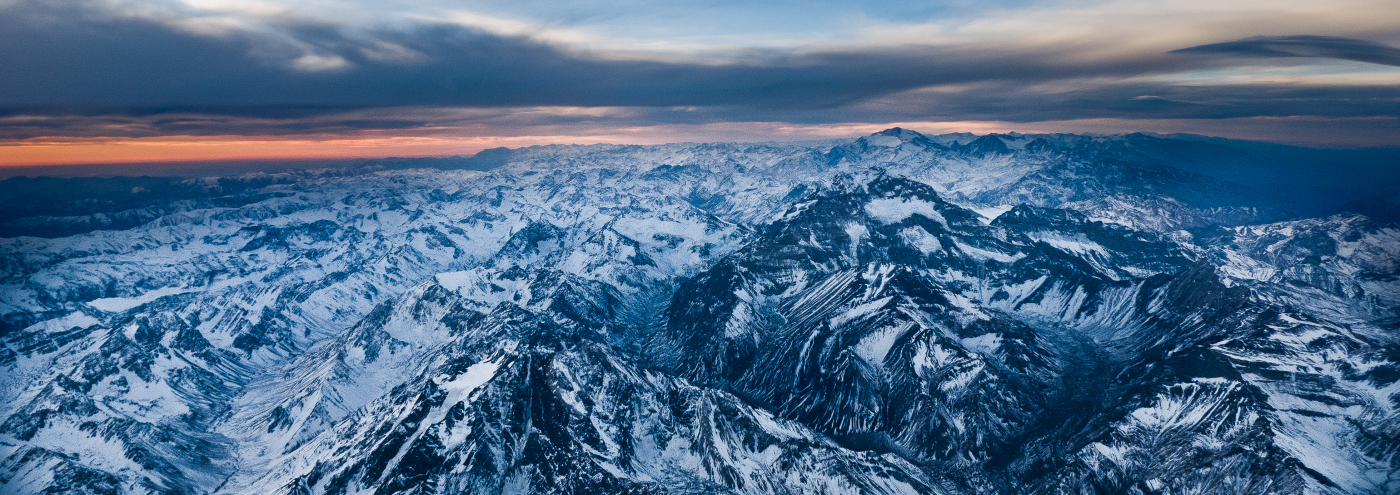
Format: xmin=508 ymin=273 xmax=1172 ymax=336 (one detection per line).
xmin=0 ymin=3 xmax=1198 ymax=113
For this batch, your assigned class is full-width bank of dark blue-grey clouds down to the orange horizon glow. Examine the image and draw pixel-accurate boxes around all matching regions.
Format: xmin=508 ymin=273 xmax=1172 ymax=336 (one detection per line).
xmin=0 ymin=1 xmax=1400 ymax=144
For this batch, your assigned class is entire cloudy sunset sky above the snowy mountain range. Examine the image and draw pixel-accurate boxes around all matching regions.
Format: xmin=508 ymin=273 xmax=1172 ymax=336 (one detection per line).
xmin=0 ymin=0 xmax=1400 ymax=165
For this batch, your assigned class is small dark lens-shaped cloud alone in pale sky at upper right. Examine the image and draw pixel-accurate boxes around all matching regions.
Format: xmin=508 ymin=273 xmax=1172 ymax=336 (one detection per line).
xmin=1172 ymin=36 xmax=1400 ymax=67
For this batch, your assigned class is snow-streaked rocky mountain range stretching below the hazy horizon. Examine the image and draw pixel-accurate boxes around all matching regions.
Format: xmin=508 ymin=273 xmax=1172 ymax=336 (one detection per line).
xmin=0 ymin=129 xmax=1400 ymax=495
